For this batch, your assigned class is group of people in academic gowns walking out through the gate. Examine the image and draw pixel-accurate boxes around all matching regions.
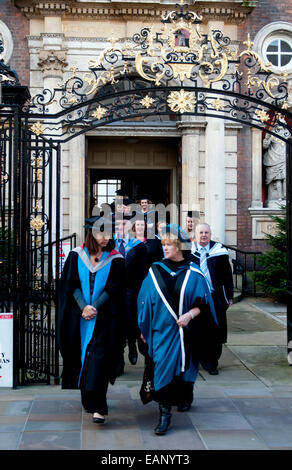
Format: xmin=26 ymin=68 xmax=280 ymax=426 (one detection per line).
xmin=58 ymin=190 xmax=233 ymax=436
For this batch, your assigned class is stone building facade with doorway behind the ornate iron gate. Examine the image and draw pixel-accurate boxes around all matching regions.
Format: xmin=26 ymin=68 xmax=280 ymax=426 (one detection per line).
xmin=0 ymin=0 xmax=292 ymax=250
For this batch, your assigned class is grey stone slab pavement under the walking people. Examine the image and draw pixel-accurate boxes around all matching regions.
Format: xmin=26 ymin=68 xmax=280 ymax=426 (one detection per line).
xmin=0 ymin=298 xmax=292 ymax=455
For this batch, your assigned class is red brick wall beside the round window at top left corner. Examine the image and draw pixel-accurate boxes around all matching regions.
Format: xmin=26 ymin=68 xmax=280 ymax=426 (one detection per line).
xmin=0 ymin=0 xmax=30 ymax=86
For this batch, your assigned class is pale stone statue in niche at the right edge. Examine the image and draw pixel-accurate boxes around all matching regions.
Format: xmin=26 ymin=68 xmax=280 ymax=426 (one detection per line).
xmin=263 ymin=118 xmax=286 ymax=209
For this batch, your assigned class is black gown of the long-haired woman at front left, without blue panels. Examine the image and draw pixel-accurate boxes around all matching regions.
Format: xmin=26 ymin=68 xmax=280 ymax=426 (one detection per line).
xmin=58 ymin=251 xmax=125 ymax=392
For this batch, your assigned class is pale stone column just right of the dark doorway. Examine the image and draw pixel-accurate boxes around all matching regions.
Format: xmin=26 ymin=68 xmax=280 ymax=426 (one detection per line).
xmin=178 ymin=120 xmax=205 ymax=227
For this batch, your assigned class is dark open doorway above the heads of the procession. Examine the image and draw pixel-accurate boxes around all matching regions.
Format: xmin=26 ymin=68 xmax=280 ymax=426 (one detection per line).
xmin=89 ymin=169 xmax=171 ymax=215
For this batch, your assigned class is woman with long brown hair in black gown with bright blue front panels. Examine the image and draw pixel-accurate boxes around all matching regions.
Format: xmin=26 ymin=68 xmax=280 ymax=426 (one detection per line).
xmin=58 ymin=217 xmax=125 ymax=424
